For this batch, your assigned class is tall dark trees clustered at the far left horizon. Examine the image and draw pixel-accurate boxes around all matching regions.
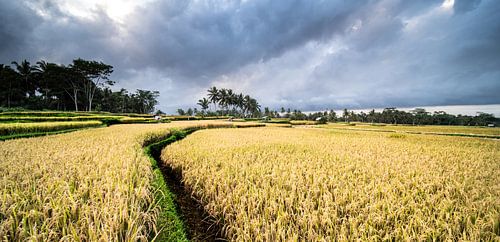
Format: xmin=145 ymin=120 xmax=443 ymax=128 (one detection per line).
xmin=0 ymin=58 xmax=159 ymax=113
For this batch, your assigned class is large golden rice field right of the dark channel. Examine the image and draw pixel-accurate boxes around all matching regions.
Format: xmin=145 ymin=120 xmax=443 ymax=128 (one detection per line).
xmin=162 ymin=127 xmax=500 ymax=241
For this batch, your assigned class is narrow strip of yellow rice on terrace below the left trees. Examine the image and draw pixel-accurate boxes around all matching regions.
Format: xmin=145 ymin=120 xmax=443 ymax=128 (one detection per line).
xmin=0 ymin=121 xmax=102 ymax=136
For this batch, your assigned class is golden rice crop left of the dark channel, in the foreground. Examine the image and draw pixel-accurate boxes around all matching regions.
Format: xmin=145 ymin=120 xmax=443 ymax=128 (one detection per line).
xmin=0 ymin=121 xmax=236 ymax=241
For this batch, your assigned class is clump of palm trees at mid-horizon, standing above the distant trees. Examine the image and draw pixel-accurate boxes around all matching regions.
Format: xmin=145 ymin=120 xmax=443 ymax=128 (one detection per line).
xmin=177 ymin=87 xmax=261 ymax=118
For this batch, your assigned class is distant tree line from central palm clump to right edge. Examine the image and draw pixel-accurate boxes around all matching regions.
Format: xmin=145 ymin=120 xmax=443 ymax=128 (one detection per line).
xmin=183 ymin=87 xmax=500 ymax=126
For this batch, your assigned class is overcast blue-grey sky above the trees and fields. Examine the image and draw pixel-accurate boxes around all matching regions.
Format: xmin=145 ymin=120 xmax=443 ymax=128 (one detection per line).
xmin=0 ymin=0 xmax=500 ymax=112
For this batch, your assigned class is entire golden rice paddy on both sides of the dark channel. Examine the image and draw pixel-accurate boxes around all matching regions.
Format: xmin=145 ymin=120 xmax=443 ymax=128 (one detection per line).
xmin=0 ymin=117 xmax=500 ymax=241
